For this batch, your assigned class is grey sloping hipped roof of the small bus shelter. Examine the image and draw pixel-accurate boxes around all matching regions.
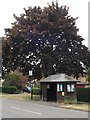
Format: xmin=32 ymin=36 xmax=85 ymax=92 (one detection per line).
xmin=40 ymin=74 xmax=80 ymax=82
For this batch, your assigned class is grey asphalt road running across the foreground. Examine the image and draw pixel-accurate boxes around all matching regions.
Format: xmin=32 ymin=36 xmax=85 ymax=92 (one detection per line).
xmin=0 ymin=99 xmax=88 ymax=118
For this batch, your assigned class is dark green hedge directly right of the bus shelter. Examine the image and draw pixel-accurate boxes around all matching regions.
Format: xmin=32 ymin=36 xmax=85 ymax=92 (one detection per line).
xmin=76 ymin=88 xmax=90 ymax=103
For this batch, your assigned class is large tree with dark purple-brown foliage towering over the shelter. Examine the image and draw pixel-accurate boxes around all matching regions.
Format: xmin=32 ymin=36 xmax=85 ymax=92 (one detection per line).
xmin=3 ymin=2 xmax=90 ymax=77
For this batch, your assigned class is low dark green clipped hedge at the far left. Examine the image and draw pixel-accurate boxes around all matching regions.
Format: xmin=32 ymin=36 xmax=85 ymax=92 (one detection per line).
xmin=2 ymin=86 xmax=18 ymax=94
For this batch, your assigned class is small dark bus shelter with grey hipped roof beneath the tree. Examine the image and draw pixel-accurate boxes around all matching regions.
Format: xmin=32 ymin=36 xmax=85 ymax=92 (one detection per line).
xmin=40 ymin=74 xmax=79 ymax=102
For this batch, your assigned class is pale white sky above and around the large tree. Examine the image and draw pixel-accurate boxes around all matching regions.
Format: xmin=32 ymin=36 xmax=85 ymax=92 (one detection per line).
xmin=0 ymin=0 xmax=88 ymax=46
